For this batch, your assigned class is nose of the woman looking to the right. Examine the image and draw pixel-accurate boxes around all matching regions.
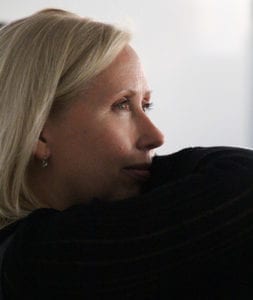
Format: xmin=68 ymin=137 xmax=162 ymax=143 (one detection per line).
xmin=137 ymin=114 xmax=164 ymax=150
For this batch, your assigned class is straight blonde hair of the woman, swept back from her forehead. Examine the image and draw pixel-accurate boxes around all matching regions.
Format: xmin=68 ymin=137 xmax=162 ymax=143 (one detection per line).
xmin=0 ymin=9 xmax=130 ymax=227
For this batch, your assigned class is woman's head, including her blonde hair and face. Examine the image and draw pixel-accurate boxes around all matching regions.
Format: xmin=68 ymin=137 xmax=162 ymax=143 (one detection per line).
xmin=1 ymin=10 xmax=163 ymax=220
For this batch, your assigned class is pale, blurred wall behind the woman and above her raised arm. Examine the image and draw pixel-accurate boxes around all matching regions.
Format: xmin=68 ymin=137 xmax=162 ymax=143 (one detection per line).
xmin=0 ymin=0 xmax=253 ymax=154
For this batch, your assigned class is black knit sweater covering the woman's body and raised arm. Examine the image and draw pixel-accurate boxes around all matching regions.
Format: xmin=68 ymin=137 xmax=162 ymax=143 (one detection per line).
xmin=0 ymin=147 xmax=253 ymax=300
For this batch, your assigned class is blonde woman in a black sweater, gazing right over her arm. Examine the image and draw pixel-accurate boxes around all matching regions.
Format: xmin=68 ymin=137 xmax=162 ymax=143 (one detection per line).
xmin=0 ymin=9 xmax=253 ymax=299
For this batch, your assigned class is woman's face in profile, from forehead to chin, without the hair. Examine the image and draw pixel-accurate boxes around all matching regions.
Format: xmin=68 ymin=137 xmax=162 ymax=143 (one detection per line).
xmin=35 ymin=46 xmax=163 ymax=209
